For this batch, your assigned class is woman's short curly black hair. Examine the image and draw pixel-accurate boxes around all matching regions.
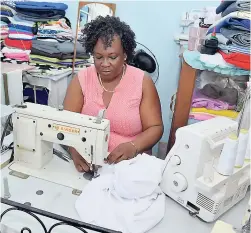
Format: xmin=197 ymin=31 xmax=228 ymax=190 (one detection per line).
xmin=82 ymin=15 xmax=136 ymax=61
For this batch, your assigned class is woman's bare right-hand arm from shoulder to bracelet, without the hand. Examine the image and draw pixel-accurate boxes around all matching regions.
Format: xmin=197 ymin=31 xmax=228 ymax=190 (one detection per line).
xmin=130 ymin=76 xmax=164 ymax=153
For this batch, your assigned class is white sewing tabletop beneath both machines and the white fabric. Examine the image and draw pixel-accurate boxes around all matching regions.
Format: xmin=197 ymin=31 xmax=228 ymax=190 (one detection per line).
xmin=1 ymin=161 xmax=250 ymax=233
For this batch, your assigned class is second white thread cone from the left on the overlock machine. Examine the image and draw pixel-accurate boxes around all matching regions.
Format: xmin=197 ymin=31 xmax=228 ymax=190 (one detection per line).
xmin=235 ymin=129 xmax=248 ymax=168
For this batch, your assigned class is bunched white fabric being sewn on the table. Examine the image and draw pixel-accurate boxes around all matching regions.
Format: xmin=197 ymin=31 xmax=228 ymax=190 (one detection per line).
xmin=75 ymin=154 xmax=165 ymax=233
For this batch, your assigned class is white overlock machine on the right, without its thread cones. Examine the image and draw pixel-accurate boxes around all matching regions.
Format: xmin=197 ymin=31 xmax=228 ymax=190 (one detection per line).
xmin=161 ymin=117 xmax=250 ymax=222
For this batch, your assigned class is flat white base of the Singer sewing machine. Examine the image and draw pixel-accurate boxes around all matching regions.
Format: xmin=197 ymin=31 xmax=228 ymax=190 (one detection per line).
xmin=9 ymin=156 xmax=89 ymax=190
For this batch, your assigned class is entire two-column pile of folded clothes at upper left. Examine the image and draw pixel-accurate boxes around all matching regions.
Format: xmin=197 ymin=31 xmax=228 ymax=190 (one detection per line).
xmin=1 ymin=1 xmax=90 ymax=70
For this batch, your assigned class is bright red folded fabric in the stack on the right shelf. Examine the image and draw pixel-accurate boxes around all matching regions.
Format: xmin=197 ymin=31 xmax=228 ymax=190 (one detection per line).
xmin=219 ymin=51 xmax=250 ymax=70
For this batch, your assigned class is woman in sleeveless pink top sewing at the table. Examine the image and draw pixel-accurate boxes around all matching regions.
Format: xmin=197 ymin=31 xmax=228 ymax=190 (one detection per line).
xmin=64 ymin=16 xmax=163 ymax=172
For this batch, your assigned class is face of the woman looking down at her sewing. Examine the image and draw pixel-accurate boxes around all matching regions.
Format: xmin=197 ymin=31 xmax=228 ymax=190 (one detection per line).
xmin=93 ymin=36 xmax=126 ymax=82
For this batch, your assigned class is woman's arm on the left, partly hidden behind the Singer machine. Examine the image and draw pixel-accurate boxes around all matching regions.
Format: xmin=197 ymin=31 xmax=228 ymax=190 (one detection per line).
xmin=64 ymin=76 xmax=89 ymax=172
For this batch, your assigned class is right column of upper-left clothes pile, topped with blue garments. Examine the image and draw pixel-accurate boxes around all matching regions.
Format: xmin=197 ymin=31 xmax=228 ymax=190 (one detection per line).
xmin=16 ymin=1 xmax=89 ymax=69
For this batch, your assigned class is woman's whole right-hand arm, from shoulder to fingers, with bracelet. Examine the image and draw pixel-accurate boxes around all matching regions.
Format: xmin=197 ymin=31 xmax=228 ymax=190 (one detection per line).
xmin=108 ymin=76 xmax=164 ymax=163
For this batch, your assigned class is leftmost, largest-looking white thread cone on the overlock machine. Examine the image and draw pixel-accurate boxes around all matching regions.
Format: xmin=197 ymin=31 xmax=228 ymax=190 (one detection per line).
xmin=217 ymin=134 xmax=238 ymax=176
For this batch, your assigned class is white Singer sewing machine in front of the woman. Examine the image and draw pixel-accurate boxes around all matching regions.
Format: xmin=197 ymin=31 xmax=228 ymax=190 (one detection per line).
xmin=9 ymin=103 xmax=110 ymax=189
